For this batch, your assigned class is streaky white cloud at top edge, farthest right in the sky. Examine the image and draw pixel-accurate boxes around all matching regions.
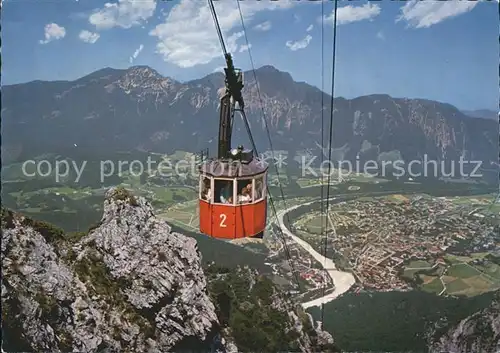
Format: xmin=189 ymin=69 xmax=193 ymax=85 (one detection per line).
xmin=396 ymin=0 xmax=478 ymax=28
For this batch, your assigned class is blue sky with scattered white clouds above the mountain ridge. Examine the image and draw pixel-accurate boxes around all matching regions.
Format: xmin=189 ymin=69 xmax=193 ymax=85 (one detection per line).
xmin=2 ymin=0 xmax=499 ymax=110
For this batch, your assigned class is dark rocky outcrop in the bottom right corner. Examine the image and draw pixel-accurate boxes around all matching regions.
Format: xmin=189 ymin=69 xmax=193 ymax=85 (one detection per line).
xmin=429 ymin=295 xmax=500 ymax=353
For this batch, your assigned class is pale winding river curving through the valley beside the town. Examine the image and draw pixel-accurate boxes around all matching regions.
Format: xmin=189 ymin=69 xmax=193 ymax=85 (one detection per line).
xmin=277 ymin=198 xmax=356 ymax=309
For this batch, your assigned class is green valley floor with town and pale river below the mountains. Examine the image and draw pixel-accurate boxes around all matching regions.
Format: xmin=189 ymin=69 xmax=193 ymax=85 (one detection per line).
xmin=2 ymin=157 xmax=500 ymax=306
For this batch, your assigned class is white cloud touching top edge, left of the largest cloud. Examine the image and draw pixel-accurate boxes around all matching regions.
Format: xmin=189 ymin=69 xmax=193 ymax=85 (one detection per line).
xmin=89 ymin=0 xmax=156 ymax=29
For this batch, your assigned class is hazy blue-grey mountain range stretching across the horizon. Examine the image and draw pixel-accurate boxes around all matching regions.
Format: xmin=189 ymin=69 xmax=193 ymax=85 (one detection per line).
xmin=2 ymin=66 xmax=499 ymax=173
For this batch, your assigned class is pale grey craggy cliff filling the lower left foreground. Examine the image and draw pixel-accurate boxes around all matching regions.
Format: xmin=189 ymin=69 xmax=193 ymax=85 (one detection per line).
xmin=2 ymin=188 xmax=333 ymax=352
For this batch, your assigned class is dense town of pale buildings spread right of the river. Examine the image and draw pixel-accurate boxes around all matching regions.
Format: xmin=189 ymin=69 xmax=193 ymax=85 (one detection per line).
xmin=294 ymin=197 xmax=494 ymax=290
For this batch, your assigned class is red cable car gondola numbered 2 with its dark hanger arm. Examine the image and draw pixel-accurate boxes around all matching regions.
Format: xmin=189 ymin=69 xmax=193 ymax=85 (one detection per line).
xmin=199 ymin=54 xmax=268 ymax=239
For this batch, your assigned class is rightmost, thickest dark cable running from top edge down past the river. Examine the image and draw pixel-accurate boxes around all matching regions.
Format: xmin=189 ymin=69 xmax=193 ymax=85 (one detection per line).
xmin=321 ymin=0 xmax=338 ymax=324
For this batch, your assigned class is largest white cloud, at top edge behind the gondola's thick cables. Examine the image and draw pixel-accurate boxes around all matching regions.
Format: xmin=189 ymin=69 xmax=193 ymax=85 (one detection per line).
xmin=149 ymin=0 xmax=305 ymax=68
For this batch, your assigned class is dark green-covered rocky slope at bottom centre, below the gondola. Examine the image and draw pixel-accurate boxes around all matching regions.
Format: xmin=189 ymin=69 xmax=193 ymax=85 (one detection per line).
xmin=207 ymin=264 xmax=338 ymax=352
